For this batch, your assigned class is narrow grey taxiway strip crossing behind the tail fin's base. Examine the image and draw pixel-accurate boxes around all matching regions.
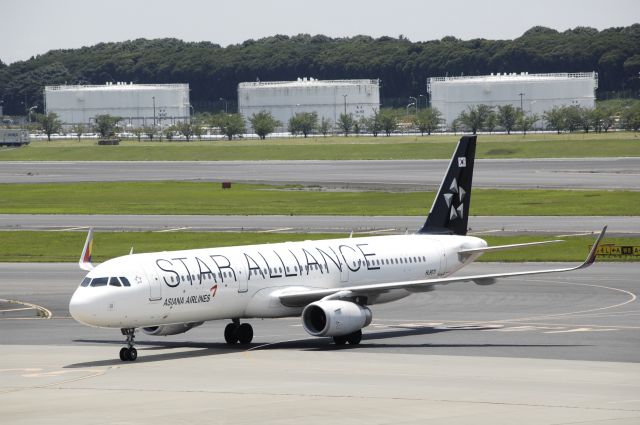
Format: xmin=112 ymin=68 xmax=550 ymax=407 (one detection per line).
xmin=0 ymin=211 xmax=640 ymax=237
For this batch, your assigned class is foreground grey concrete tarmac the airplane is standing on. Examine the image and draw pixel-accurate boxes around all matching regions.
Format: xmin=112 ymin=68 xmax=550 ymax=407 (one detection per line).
xmin=0 ymin=263 xmax=640 ymax=424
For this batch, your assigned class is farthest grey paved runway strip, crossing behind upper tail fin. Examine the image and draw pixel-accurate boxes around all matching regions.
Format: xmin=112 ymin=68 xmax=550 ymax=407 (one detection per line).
xmin=0 ymin=157 xmax=640 ymax=190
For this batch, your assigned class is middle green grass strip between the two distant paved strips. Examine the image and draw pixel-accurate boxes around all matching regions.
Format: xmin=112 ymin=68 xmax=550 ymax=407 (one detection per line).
xmin=0 ymin=182 xmax=640 ymax=216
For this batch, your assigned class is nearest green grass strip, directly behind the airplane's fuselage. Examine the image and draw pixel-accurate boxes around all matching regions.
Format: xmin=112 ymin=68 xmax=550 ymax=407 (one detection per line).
xmin=0 ymin=231 xmax=640 ymax=263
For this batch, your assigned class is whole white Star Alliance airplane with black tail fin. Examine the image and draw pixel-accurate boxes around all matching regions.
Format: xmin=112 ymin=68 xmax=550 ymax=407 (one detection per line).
xmin=69 ymin=136 xmax=606 ymax=361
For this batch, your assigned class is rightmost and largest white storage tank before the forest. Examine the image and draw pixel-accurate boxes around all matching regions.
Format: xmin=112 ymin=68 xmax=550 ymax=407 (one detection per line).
xmin=427 ymin=72 xmax=598 ymax=126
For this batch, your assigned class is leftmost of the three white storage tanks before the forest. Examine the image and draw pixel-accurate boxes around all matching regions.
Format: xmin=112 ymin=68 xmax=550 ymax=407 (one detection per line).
xmin=44 ymin=83 xmax=190 ymax=128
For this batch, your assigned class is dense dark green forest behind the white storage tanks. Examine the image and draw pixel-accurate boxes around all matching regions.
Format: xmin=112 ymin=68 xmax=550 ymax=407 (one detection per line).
xmin=0 ymin=24 xmax=640 ymax=115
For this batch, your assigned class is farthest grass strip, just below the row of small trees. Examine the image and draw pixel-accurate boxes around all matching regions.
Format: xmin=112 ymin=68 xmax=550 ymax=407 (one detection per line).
xmin=0 ymin=132 xmax=640 ymax=161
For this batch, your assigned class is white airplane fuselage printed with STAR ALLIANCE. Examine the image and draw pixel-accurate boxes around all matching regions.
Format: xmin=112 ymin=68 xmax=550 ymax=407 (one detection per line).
xmin=69 ymin=234 xmax=486 ymax=328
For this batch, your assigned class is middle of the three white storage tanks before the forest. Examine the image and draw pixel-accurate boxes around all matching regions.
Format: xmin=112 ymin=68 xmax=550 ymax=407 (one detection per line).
xmin=238 ymin=78 xmax=380 ymax=130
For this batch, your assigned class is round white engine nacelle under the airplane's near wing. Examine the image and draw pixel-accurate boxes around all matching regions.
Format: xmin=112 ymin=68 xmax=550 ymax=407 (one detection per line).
xmin=302 ymin=300 xmax=373 ymax=336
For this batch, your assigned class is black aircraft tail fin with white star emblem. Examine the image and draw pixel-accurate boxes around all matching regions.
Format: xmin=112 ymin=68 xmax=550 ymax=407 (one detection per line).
xmin=418 ymin=136 xmax=476 ymax=235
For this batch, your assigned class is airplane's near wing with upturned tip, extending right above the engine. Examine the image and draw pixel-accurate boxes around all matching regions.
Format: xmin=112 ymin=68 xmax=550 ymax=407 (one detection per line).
xmin=278 ymin=226 xmax=607 ymax=307
